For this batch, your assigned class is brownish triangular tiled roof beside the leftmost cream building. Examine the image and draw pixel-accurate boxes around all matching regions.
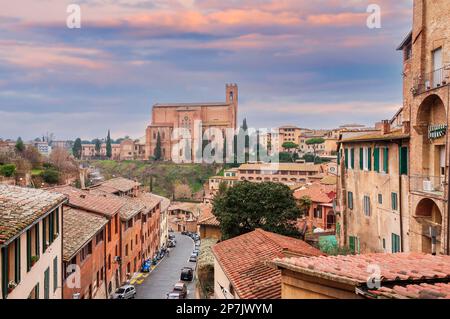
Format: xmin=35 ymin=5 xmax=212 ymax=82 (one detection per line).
xmin=63 ymin=207 xmax=108 ymax=261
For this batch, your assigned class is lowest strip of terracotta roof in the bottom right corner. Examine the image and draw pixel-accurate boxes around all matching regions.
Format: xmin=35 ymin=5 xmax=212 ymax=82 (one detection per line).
xmin=369 ymin=283 xmax=450 ymax=299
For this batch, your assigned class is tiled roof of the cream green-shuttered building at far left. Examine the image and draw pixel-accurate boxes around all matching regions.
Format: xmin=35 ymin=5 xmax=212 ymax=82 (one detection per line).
xmin=0 ymin=184 xmax=66 ymax=245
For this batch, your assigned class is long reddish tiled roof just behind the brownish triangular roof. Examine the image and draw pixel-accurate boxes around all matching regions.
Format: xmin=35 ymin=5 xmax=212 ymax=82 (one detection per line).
xmin=50 ymin=186 xmax=123 ymax=217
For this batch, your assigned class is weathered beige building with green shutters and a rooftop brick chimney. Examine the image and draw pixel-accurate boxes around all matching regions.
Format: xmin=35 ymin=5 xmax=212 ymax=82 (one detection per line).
xmin=336 ymin=121 xmax=409 ymax=253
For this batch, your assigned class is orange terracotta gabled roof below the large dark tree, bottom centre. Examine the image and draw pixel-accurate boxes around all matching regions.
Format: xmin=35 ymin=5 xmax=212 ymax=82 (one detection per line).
xmin=213 ymin=229 xmax=323 ymax=299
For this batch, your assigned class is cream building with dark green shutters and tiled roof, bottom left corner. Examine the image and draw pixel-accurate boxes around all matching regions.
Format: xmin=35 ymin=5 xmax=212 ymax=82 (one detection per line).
xmin=0 ymin=185 xmax=67 ymax=299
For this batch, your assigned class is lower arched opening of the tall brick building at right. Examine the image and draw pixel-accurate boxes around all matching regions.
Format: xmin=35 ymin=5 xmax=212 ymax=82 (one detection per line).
xmin=414 ymin=198 xmax=442 ymax=254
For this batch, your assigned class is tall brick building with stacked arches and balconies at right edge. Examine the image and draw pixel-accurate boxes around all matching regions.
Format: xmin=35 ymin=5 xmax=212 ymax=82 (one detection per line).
xmin=398 ymin=0 xmax=450 ymax=254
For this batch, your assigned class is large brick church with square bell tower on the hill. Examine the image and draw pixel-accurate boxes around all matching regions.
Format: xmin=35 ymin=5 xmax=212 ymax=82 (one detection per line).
xmin=145 ymin=84 xmax=238 ymax=161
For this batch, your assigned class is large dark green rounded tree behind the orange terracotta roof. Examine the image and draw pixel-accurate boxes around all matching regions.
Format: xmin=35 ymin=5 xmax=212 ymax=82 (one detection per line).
xmin=213 ymin=182 xmax=300 ymax=239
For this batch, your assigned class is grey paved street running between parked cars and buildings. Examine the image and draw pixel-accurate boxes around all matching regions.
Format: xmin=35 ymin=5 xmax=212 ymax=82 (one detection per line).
xmin=136 ymin=233 xmax=195 ymax=299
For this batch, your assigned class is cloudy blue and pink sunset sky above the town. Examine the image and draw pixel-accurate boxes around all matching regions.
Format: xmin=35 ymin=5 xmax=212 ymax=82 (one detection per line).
xmin=0 ymin=0 xmax=412 ymax=140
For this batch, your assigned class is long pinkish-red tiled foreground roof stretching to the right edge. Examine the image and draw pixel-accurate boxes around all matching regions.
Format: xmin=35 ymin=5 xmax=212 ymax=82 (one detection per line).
xmin=274 ymin=253 xmax=450 ymax=285
